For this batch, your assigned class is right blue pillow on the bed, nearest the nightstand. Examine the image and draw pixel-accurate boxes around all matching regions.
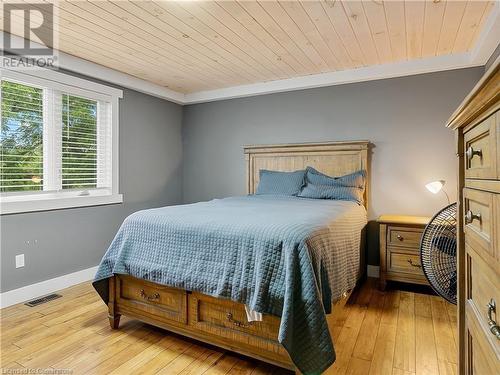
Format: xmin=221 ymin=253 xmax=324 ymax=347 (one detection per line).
xmin=298 ymin=167 xmax=366 ymax=204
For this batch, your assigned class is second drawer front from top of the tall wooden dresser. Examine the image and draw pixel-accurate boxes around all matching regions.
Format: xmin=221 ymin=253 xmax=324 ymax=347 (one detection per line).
xmin=462 ymin=189 xmax=498 ymax=263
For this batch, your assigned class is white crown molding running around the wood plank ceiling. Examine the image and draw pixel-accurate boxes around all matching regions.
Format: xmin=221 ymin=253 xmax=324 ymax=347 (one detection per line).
xmin=0 ymin=12 xmax=500 ymax=105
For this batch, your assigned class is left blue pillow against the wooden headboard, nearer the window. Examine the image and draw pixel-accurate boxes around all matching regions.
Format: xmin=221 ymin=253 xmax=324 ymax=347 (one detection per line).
xmin=255 ymin=169 xmax=306 ymax=195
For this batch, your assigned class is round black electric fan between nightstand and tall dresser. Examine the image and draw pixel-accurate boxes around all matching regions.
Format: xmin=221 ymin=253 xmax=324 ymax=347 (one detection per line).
xmin=420 ymin=203 xmax=457 ymax=305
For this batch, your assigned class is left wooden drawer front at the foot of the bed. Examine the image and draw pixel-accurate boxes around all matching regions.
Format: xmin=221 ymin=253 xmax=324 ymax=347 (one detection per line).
xmin=116 ymin=276 xmax=187 ymax=324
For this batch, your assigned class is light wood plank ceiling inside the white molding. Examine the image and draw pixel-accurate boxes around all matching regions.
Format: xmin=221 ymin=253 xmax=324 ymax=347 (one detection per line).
xmin=2 ymin=0 xmax=494 ymax=93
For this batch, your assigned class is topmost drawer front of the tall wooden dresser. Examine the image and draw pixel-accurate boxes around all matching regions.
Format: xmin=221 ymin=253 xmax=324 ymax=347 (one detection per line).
xmin=464 ymin=114 xmax=498 ymax=179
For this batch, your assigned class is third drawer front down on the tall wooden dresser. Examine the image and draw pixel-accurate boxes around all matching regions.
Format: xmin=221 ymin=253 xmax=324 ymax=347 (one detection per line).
xmin=465 ymin=244 xmax=500 ymax=360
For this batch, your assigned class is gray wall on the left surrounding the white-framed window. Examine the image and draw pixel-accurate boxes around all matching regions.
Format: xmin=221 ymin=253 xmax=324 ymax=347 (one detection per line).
xmin=0 ymin=86 xmax=182 ymax=292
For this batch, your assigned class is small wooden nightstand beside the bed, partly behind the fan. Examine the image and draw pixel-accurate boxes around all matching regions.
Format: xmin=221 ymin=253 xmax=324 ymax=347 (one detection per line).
xmin=377 ymin=215 xmax=430 ymax=290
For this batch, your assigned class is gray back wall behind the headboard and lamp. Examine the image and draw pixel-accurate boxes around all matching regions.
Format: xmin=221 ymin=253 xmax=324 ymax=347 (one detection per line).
xmin=183 ymin=68 xmax=483 ymax=264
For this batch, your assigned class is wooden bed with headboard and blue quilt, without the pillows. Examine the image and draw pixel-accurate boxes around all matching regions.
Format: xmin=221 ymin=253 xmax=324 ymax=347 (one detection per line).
xmin=94 ymin=141 xmax=370 ymax=373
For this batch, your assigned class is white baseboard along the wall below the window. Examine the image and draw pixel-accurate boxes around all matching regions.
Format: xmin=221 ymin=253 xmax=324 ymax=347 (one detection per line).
xmin=0 ymin=266 xmax=97 ymax=308
